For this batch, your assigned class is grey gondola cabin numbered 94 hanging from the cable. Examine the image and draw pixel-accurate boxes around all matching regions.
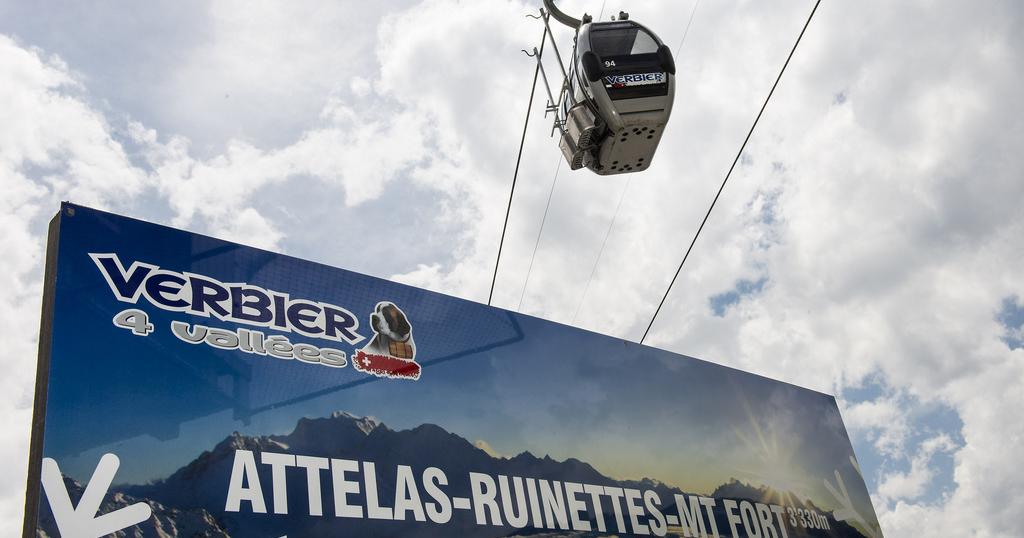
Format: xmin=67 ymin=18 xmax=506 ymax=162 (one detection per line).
xmin=545 ymin=0 xmax=676 ymax=175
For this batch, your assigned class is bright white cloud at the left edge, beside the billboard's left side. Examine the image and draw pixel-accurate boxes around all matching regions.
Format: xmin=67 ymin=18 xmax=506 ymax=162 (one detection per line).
xmin=0 ymin=35 xmax=145 ymax=535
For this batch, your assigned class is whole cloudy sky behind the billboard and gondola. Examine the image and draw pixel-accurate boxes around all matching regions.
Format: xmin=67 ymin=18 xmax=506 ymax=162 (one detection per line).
xmin=0 ymin=0 xmax=1024 ymax=537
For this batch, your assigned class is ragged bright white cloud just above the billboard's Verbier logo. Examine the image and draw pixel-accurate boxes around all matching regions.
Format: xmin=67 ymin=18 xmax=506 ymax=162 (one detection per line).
xmin=133 ymin=94 xmax=441 ymax=249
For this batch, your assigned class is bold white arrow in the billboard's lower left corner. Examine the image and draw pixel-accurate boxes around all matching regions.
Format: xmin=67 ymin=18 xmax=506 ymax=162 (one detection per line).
xmin=42 ymin=454 xmax=153 ymax=538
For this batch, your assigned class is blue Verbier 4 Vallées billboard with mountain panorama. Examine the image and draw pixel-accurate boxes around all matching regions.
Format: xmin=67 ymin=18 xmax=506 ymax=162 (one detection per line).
xmin=25 ymin=204 xmax=881 ymax=538
